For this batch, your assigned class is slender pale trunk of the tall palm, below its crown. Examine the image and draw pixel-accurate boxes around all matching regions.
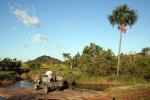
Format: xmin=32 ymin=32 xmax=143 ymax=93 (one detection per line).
xmin=117 ymin=31 xmax=122 ymax=77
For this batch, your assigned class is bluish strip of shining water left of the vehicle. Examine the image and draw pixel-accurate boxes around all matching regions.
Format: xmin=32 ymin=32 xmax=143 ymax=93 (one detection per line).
xmin=0 ymin=80 xmax=32 ymax=88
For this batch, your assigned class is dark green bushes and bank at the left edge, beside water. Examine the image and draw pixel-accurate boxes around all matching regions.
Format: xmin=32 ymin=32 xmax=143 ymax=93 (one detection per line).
xmin=0 ymin=58 xmax=22 ymax=83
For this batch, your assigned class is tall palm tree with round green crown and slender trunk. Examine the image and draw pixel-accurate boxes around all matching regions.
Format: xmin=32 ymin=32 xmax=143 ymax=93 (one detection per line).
xmin=108 ymin=4 xmax=138 ymax=76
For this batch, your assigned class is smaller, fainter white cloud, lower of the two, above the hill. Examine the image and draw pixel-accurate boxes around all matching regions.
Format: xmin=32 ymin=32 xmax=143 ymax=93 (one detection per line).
xmin=32 ymin=34 xmax=47 ymax=44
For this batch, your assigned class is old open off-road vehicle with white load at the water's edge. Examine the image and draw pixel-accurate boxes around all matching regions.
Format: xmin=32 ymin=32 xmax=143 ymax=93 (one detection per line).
xmin=33 ymin=71 xmax=64 ymax=93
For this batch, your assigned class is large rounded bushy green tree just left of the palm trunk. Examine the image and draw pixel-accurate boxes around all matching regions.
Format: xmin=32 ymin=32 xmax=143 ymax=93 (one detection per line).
xmin=64 ymin=43 xmax=115 ymax=76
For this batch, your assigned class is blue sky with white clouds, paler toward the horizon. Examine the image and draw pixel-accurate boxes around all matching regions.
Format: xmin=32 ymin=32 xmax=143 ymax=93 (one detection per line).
xmin=0 ymin=0 xmax=150 ymax=61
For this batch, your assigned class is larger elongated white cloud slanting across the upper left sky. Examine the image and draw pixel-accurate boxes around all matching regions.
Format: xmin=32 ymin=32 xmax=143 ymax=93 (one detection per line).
xmin=12 ymin=8 xmax=40 ymax=27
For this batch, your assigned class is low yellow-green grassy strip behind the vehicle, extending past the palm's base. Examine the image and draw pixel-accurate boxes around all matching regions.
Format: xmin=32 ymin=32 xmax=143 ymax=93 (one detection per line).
xmin=27 ymin=65 xmax=149 ymax=85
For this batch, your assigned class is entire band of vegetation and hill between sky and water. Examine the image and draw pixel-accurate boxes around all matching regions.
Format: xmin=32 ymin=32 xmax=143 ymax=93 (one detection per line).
xmin=0 ymin=43 xmax=150 ymax=84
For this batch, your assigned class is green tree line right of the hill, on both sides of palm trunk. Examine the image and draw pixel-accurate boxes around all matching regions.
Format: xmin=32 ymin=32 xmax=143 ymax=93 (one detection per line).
xmin=63 ymin=43 xmax=150 ymax=81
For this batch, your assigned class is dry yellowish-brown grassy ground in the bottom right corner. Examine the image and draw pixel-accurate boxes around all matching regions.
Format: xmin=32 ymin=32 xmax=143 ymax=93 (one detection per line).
xmin=105 ymin=84 xmax=150 ymax=100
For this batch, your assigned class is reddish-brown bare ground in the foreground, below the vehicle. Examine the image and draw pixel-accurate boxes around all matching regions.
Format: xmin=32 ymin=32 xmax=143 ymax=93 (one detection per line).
xmin=0 ymin=88 xmax=111 ymax=100
